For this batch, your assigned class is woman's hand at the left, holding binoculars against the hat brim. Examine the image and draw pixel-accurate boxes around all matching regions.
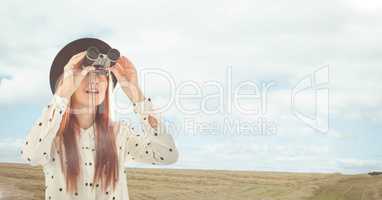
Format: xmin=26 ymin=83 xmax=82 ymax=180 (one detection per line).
xmin=56 ymin=51 xmax=95 ymax=99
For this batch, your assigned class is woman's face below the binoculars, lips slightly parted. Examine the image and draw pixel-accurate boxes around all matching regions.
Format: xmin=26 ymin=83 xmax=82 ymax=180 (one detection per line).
xmin=72 ymin=71 xmax=108 ymax=107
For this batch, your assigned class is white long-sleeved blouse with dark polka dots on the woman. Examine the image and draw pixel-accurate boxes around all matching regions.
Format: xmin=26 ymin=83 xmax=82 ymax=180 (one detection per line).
xmin=20 ymin=95 xmax=178 ymax=200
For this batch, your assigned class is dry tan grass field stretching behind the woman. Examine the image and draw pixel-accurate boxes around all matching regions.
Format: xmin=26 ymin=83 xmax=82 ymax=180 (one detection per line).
xmin=0 ymin=163 xmax=382 ymax=200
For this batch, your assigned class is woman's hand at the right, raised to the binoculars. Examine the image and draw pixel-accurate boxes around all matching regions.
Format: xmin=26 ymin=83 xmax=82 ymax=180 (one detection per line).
xmin=110 ymin=56 xmax=144 ymax=103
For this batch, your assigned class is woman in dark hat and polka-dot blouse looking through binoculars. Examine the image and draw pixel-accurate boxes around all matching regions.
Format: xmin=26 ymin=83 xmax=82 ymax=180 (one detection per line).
xmin=21 ymin=38 xmax=178 ymax=200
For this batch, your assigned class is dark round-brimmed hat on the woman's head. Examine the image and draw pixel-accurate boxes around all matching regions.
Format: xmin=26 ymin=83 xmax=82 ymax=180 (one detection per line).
xmin=50 ymin=38 xmax=117 ymax=94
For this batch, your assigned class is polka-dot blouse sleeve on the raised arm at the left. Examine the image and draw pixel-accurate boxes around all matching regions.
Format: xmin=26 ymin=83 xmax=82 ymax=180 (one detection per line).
xmin=20 ymin=95 xmax=69 ymax=166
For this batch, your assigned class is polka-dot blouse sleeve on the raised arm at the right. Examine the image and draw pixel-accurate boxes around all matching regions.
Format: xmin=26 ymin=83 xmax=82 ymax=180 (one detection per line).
xmin=120 ymin=97 xmax=178 ymax=165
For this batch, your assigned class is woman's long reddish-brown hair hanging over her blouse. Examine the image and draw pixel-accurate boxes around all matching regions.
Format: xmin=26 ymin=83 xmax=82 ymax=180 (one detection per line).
xmin=55 ymin=74 xmax=119 ymax=192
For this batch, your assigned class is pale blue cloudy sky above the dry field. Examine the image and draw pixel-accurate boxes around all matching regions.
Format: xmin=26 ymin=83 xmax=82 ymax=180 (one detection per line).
xmin=0 ymin=0 xmax=382 ymax=174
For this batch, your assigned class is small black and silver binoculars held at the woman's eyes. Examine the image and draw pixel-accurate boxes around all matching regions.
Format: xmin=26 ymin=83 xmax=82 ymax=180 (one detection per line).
xmin=82 ymin=46 xmax=120 ymax=74
